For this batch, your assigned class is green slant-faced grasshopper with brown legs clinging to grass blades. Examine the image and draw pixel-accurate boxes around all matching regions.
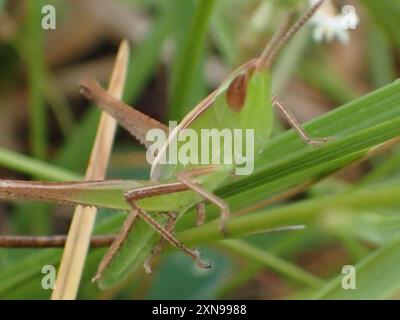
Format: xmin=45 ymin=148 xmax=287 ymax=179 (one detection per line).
xmin=0 ymin=0 xmax=326 ymax=286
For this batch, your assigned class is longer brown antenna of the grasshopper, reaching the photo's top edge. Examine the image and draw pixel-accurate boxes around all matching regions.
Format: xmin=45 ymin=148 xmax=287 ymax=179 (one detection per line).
xmin=257 ymin=0 xmax=325 ymax=69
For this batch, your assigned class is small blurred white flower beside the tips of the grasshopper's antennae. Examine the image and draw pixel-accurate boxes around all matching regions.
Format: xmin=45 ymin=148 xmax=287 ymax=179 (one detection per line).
xmin=309 ymin=0 xmax=359 ymax=43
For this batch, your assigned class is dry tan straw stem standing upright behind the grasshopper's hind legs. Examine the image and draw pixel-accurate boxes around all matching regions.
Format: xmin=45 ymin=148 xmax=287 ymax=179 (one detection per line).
xmin=51 ymin=40 xmax=129 ymax=300
